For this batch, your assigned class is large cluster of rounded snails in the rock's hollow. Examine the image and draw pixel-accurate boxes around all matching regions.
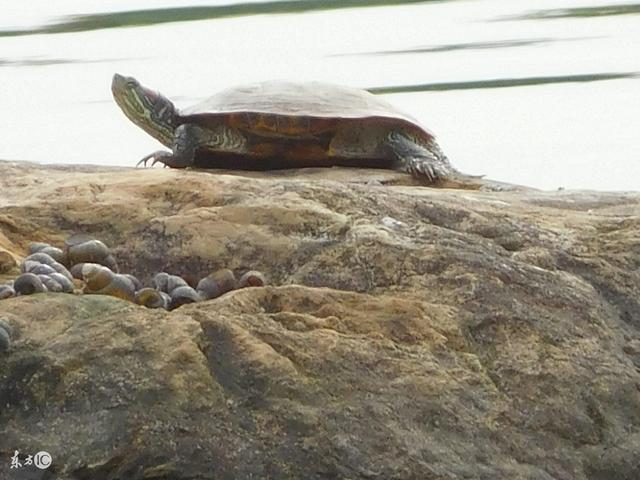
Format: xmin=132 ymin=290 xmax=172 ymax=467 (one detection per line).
xmin=0 ymin=235 xmax=265 ymax=314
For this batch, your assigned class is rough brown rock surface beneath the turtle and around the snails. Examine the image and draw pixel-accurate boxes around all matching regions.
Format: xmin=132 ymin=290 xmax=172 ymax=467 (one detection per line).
xmin=0 ymin=162 xmax=640 ymax=480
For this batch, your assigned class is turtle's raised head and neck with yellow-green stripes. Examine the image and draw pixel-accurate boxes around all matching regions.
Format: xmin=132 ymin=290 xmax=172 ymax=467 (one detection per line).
xmin=111 ymin=73 xmax=177 ymax=147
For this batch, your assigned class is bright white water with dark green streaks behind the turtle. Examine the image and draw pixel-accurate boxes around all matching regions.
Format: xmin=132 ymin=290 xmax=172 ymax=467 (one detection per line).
xmin=0 ymin=0 xmax=640 ymax=190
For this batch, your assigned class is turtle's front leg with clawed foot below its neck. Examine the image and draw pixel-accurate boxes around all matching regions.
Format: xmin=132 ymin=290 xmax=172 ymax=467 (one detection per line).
xmin=136 ymin=123 xmax=245 ymax=168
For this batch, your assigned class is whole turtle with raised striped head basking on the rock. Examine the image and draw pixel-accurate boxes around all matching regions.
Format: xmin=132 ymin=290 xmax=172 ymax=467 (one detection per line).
xmin=111 ymin=73 xmax=475 ymax=184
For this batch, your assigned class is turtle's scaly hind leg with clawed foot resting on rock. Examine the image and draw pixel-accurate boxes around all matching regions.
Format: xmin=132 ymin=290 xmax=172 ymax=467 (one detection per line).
xmin=384 ymin=132 xmax=456 ymax=183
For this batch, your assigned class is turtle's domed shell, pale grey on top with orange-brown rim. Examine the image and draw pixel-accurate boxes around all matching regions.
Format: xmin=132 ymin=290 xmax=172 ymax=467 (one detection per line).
xmin=178 ymin=81 xmax=434 ymax=141
